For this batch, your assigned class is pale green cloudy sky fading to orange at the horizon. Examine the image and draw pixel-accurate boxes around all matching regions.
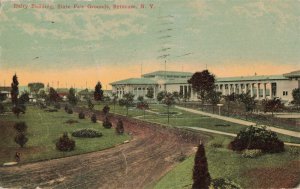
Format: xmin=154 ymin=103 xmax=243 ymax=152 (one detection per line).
xmin=0 ymin=0 xmax=300 ymax=89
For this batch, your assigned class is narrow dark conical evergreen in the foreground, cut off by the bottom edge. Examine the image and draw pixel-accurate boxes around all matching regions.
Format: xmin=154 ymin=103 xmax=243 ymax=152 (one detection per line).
xmin=192 ymin=143 xmax=211 ymax=189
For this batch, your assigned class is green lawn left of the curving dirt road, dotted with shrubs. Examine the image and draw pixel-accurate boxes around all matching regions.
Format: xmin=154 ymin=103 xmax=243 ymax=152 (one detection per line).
xmin=0 ymin=106 xmax=130 ymax=164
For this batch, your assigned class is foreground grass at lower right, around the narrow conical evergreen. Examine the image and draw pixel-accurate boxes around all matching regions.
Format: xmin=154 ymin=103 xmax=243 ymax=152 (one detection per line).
xmin=154 ymin=135 xmax=300 ymax=189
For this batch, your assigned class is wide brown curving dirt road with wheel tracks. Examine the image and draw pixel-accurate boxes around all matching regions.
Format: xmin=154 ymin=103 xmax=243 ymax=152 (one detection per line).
xmin=0 ymin=109 xmax=206 ymax=188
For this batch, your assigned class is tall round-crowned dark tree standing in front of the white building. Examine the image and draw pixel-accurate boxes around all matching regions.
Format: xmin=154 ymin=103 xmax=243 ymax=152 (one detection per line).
xmin=188 ymin=70 xmax=215 ymax=108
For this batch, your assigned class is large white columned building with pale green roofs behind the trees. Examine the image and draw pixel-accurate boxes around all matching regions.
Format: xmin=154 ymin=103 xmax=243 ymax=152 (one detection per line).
xmin=111 ymin=70 xmax=300 ymax=101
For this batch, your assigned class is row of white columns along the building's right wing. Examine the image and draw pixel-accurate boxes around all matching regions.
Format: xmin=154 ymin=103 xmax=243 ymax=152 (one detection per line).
xmin=216 ymin=82 xmax=273 ymax=99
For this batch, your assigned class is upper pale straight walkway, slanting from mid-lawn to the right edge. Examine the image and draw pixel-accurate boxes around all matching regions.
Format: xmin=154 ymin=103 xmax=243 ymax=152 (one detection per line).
xmin=175 ymin=106 xmax=300 ymax=138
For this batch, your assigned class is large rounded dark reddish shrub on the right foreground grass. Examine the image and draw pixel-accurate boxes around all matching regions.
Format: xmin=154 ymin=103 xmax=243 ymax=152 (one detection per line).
xmin=230 ymin=126 xmax=284 ymax=153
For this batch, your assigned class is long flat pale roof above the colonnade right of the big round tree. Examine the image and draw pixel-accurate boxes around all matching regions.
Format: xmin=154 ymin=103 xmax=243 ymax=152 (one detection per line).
xmin=216 ymin=75 xmax=288 ymax=82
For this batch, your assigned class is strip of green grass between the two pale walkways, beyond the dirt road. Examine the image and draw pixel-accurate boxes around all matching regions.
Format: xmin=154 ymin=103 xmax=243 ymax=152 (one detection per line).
xmin=91 ymin=104 xmax=300 ymax=144
